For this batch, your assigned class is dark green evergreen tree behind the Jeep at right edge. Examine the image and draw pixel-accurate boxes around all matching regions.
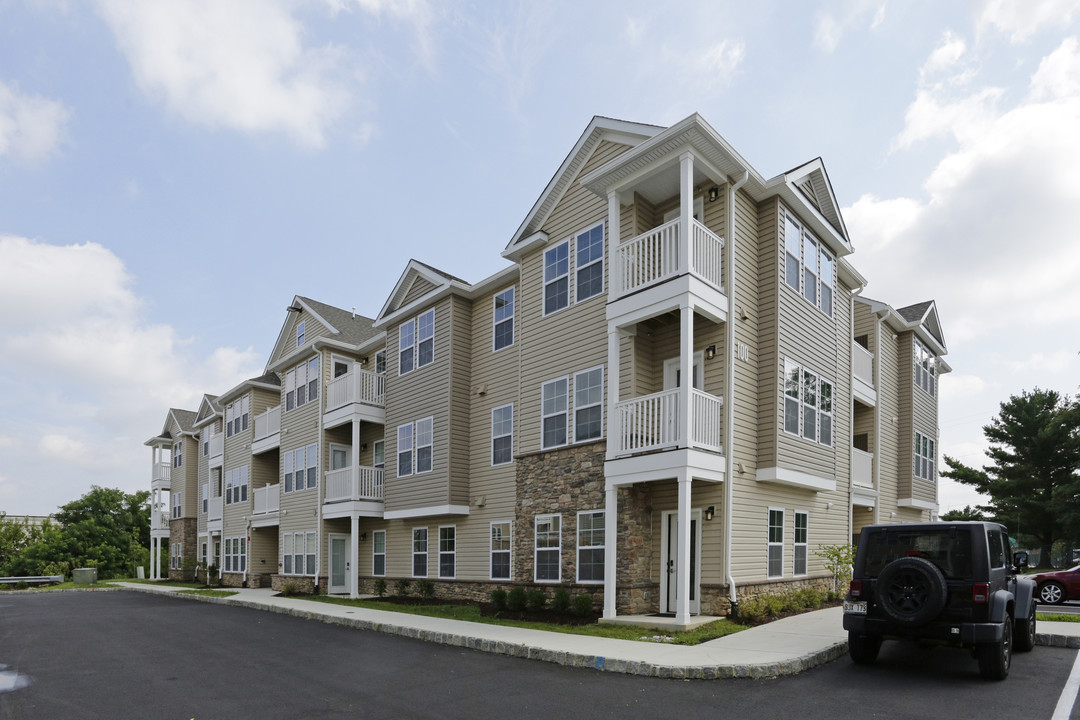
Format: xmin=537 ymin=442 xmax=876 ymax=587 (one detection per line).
xmin=942 ymin=388 xmax=1080 ymax=565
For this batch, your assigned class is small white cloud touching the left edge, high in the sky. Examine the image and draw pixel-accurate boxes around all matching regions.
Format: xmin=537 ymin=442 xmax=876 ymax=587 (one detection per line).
xmin=0 ymin=82 xmax=70 ymax=164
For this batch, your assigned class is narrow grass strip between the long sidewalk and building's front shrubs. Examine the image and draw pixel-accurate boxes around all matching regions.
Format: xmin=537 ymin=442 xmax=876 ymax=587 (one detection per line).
xmin=303 ymin=595 xmax=746 ymax=646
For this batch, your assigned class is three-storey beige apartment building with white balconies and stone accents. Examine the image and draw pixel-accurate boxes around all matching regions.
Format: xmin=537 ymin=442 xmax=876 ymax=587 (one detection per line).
xmin=143 ymin=114 xmax=949 ymax=621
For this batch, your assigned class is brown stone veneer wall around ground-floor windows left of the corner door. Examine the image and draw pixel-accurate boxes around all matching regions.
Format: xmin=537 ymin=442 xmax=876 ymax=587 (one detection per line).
xmin=513 ymin=440 xmax=658 ymax=614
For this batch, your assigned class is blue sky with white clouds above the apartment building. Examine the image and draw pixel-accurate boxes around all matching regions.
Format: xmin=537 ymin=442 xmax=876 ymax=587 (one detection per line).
xmin=0 ymin=0 xmax=1080 ymax=514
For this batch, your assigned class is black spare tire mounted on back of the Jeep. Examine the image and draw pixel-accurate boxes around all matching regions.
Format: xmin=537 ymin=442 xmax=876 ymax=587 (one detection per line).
xmin=876 ymin=557 xmax=948 ymax=627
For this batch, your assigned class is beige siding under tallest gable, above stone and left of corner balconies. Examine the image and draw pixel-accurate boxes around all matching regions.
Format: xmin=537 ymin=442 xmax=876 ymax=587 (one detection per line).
xmin=514 ymin=141 xmax=627 ymax=454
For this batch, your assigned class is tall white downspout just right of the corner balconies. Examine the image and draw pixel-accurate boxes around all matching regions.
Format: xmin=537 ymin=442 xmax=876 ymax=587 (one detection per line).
xmin=724 ymin=169 xmax=750 ymax=608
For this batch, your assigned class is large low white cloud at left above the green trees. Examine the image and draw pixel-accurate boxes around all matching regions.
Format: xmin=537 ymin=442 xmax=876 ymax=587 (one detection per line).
xmin=0 ymin=235 xmax=260 ymax=514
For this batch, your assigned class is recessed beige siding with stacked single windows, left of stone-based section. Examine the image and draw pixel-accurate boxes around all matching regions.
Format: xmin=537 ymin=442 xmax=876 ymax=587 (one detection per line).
xmin=456 ymin=286 xmax=521 ymax=581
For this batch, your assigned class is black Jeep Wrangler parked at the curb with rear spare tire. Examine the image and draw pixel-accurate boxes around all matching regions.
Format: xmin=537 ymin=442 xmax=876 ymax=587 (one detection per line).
xmin=843 ymin=522 xmax=1036 ymax=680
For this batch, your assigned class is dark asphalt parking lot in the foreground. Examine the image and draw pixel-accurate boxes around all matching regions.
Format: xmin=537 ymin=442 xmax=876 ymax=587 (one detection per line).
xmin=0 ymin=593 xmax=1080 ymax=720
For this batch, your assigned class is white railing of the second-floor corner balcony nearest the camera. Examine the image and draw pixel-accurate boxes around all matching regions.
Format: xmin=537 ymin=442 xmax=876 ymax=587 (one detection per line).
xmin=609 ymin=388 xmax=724 ymax=458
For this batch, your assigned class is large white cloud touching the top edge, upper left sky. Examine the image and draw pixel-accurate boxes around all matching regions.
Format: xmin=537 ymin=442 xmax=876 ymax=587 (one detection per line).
xmin=98 ymin=0 xmax=350 ymax=148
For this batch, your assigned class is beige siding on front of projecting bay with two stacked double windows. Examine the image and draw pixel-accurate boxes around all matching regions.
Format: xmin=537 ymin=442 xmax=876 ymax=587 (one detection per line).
xmin=383 ymin=298 xmax=453 ymax=511
